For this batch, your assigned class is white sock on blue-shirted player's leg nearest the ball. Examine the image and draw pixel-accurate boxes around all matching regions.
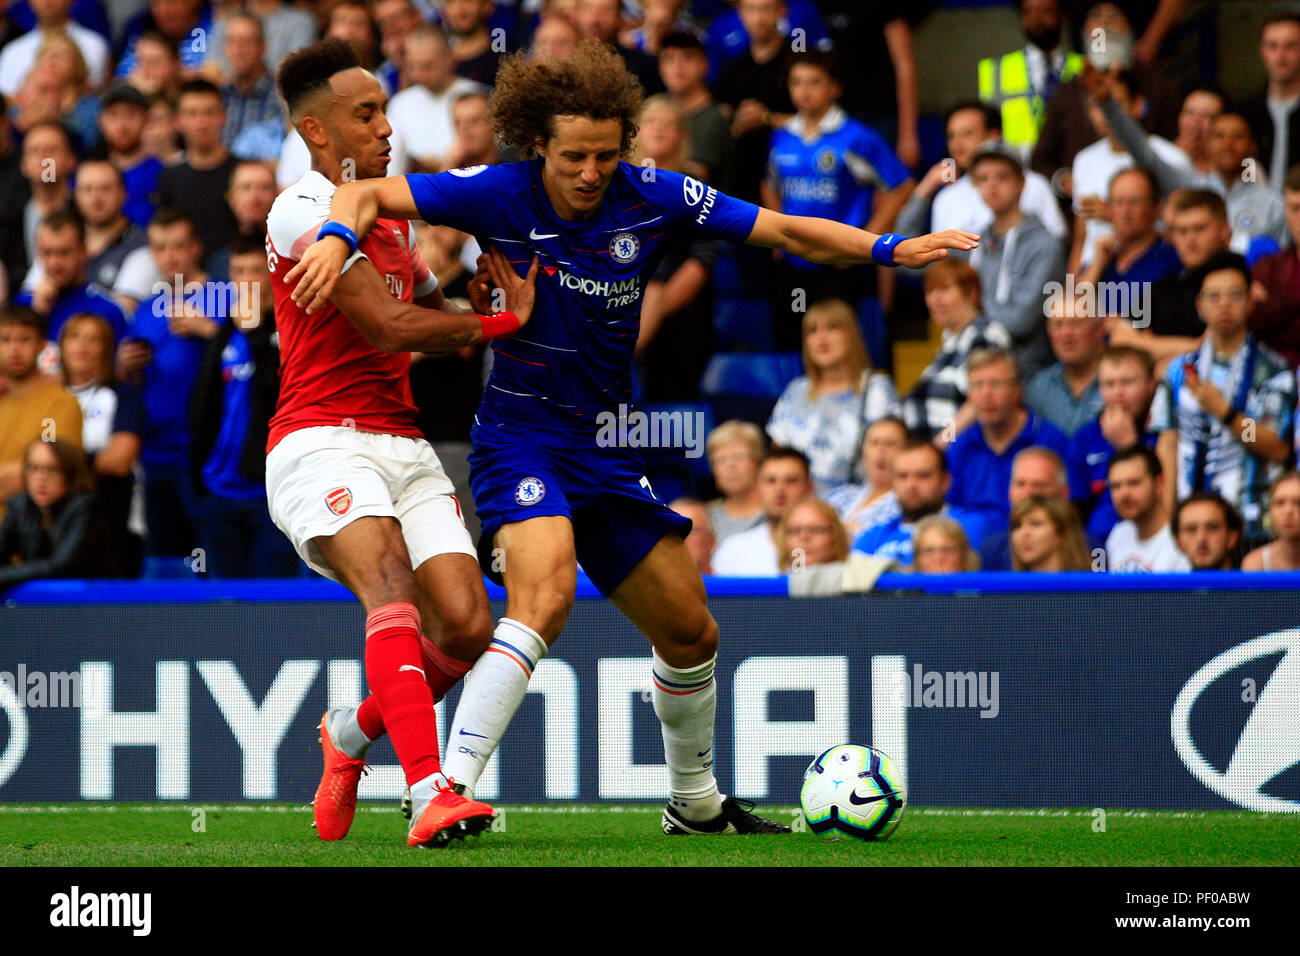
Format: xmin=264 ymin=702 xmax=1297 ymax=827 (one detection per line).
xmin=653 ymin=653 xmax=723 ymax=821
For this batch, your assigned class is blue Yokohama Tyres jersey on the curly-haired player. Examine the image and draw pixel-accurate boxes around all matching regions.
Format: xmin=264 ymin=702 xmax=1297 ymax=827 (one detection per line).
xmin=407 ymin=159 xmax=758 ymax=433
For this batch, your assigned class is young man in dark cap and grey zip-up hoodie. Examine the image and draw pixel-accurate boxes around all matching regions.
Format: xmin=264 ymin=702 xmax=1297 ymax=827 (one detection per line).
xmin=970 ymin=140 xmax=1065 ymax=378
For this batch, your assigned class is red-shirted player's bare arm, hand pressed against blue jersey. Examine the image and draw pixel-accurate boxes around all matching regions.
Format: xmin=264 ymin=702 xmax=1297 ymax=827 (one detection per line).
xmin=330 ymin=248 xmax=538 ymax=352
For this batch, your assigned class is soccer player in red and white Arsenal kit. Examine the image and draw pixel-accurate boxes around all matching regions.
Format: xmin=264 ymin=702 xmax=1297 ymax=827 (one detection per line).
xmin=267 ymin=40 xmax=536 ymax=845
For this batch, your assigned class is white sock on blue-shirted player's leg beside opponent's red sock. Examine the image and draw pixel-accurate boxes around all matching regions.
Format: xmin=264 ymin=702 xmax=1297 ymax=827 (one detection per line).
xmin=442 ymin=618 xmax=546 ymax=797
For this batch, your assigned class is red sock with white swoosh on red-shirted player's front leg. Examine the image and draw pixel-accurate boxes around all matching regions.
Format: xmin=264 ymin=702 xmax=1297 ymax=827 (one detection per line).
xmin=365 ymin=601 xmax=439 ymax=783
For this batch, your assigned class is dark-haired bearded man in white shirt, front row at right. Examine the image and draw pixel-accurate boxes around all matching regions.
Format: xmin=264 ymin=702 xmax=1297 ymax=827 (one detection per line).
xmin=1106 ymin=445 xmax=1192 ymax=572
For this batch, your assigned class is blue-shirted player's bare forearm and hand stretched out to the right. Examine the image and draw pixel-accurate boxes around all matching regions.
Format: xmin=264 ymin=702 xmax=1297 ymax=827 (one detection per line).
xmin=748 ymin=209 xmax=979 ymax=269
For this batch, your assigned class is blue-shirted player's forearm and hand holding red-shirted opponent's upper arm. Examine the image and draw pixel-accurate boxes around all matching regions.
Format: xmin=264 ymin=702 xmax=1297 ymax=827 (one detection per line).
xmin=285 ymin=176 xmax=420 ymax=315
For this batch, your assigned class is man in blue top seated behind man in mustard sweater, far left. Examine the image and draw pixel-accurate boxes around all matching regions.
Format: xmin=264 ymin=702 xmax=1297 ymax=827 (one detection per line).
xmin=13 ymin=209 xmax=126 ymax=342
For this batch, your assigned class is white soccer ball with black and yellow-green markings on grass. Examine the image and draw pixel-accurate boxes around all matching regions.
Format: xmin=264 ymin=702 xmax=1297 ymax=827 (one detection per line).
xmin=800 ymin=744 xmax=906 ymax=840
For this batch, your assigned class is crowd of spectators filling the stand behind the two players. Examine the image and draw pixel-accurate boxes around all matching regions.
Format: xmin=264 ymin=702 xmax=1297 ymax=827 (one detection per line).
xmin=0 ymin=0 xmax=1300 ymax=584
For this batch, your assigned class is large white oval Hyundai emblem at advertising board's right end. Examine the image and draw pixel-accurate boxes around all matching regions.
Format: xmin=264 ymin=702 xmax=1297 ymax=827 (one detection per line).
xmin=1169 ymin=628 xmax=1300 ymax=813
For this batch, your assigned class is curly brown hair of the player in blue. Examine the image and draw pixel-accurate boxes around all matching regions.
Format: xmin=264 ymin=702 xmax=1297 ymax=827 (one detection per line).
xmin=488 ymin=40 xmax=645 ymax=156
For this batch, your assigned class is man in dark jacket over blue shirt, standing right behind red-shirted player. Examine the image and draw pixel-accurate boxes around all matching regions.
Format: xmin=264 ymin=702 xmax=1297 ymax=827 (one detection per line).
xmin=190 ymin=235 xmax=298 ymax=578
